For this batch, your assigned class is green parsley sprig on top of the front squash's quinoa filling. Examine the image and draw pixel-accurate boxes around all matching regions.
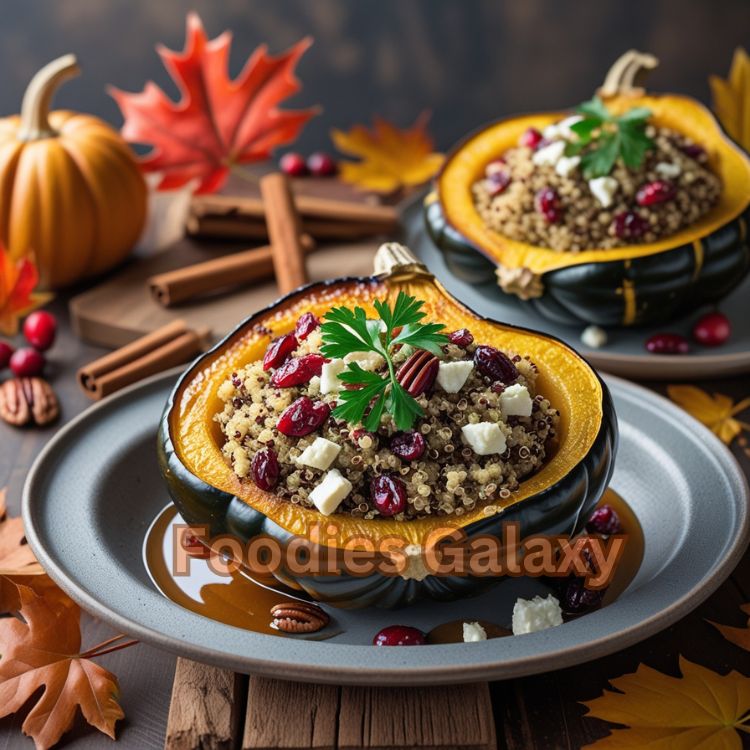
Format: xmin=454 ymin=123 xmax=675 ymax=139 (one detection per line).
xmin=320 ymin=292 xmax=448 ymax=432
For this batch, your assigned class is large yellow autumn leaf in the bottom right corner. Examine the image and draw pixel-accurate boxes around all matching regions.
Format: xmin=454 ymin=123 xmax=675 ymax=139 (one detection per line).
xmin=584 ymin=657 xmax=750 ymax=750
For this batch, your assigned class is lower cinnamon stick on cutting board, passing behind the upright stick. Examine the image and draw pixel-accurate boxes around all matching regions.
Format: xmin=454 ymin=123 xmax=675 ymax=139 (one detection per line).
xmin=146 ymin=234 xmax=315 ymax=307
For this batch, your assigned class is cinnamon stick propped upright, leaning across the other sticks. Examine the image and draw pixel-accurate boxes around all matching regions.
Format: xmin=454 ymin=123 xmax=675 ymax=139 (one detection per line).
xmin=260 ymin=172 xmax=308 ymax=294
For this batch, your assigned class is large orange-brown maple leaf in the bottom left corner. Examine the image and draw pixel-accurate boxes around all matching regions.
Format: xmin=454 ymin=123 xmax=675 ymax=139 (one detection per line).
xmin=0 ymin=586 xmax=124 ymax=750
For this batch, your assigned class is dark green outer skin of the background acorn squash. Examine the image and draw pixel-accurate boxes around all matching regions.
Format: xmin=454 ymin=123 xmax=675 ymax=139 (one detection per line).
xmin=424 ymin=197 xmax=750 ymax=326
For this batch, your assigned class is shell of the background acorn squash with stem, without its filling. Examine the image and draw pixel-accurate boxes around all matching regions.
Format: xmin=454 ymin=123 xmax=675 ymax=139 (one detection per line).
xmin=424 ymin=53 xmax=750 ymax=326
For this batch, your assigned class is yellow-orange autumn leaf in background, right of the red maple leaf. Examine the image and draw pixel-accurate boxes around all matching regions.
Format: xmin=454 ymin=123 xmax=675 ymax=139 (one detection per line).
xmin=331 ymin=113 xmax=445 ymax=193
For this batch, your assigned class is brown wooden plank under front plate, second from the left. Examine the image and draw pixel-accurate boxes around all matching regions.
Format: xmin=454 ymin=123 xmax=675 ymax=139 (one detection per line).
xmin=242 ymin=677 xmax=339 ymax=750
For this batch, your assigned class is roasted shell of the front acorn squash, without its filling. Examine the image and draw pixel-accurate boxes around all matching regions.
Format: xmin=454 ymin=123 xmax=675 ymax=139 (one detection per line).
xmin=159 ymin=245 xmax=617 ymax=608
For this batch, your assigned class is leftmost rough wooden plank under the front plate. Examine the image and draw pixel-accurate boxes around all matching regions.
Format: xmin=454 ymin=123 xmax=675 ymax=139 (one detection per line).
xmin=164 ymin=658 xmax=247 ymax=750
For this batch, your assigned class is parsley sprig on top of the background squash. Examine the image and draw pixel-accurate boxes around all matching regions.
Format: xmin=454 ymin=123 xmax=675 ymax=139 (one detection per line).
xmin=565 ymin=96 xmax=654 ymax=180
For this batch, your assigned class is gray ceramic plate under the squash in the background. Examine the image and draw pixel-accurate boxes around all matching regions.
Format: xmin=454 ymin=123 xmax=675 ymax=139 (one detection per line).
xmin=402 ymin=198 xmax=750 ymax=380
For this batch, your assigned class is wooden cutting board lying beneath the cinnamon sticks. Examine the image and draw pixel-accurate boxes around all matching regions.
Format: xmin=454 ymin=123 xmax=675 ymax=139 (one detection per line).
xmin=69 ymin=239 xmax=380 ymax=349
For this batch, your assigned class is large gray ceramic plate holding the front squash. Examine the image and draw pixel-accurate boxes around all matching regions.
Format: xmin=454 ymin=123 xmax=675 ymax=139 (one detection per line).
xmin=23 ymin=372 xmax=748 ymax=685
